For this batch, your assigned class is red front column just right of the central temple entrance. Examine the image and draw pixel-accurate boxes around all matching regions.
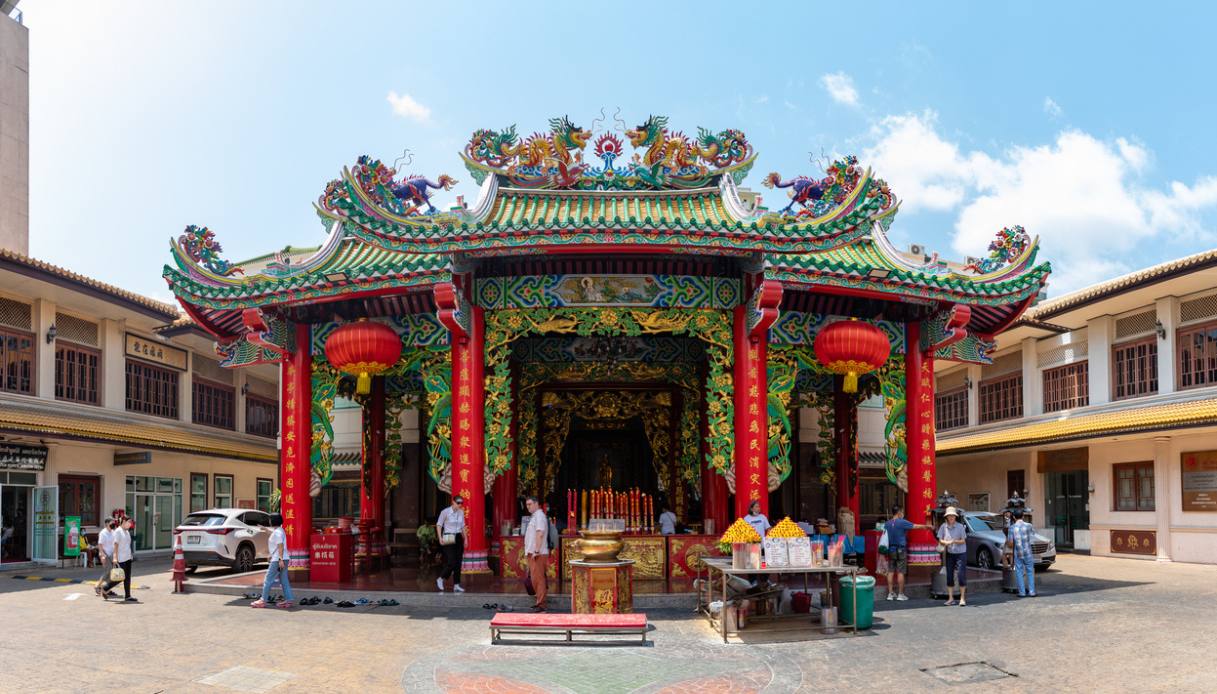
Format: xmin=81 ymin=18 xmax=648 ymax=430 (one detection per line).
xmin=724 ymin=306 xmax=769 ymax=513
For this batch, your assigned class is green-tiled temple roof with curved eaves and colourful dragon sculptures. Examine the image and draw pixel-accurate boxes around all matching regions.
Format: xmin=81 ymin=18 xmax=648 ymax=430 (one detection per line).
xmin=164 ymin=117 xmax=1049 ymax=335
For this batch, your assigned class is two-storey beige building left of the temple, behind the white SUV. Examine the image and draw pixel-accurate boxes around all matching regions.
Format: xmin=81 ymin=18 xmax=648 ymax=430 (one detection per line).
xmin=0 ymin=250 xmax=279 ymax=565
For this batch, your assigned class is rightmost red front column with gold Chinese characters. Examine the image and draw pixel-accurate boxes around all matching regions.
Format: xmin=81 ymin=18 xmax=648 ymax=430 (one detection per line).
xmin=904 ymin=323 xmax=938 ymax=565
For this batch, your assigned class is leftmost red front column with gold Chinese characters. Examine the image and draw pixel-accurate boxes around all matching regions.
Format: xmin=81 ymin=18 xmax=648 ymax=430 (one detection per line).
xmin=279 ymin=325 xmax=313 ymax=577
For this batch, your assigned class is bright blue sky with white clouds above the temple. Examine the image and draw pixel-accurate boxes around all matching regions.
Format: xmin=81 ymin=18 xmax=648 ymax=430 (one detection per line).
xmin=22 ymin=0 xmax=1217 ymax=298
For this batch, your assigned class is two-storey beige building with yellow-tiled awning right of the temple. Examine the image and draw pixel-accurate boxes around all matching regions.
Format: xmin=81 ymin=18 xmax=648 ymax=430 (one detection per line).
xmin=936 ymin=251 xmax=1217 ymax=563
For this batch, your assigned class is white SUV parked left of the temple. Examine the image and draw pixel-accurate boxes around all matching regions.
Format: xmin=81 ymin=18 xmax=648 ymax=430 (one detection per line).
xmin=174 ymin=509 xmax=270 ymax=572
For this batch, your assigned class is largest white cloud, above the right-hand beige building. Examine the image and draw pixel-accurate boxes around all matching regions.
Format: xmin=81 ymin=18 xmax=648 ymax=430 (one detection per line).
xmin=863 ymin=111 xmax=1217 ymax=295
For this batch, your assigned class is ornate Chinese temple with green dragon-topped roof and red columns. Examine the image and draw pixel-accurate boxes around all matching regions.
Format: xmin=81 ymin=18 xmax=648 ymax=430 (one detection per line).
xmin=164 ymin=116 xmax=1049 ymax=576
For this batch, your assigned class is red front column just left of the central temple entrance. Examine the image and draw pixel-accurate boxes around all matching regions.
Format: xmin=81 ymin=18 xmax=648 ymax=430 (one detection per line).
xmin=452 ymin=307 xmax=489 ymax=573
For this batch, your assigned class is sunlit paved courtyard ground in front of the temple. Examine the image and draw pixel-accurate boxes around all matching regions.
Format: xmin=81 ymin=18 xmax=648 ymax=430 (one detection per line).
xmin=0 ymin=555 xmax=1217 ymax=694
